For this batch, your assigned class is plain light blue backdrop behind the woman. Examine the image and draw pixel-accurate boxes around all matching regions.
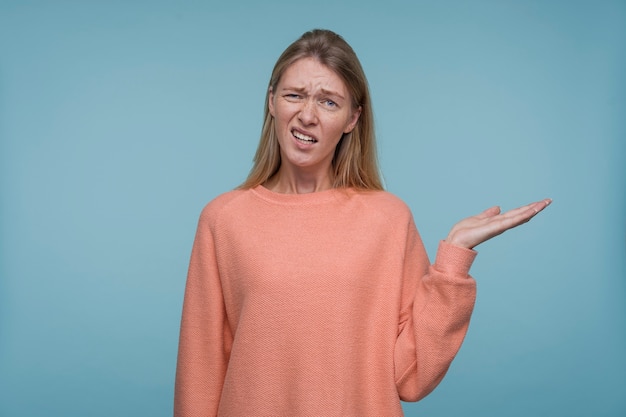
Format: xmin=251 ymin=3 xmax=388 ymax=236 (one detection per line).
xmin=0 ymin=0 xmax=626 ymax=417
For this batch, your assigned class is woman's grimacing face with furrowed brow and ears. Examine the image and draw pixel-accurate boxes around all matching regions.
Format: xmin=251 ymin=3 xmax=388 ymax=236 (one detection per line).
xmin=269 ymin=58 xmax=361 ymax=175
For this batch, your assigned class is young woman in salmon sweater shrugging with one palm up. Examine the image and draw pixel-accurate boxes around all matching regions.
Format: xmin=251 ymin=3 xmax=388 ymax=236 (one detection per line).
xmin=174 ymin=30 xmax=550 ymax=417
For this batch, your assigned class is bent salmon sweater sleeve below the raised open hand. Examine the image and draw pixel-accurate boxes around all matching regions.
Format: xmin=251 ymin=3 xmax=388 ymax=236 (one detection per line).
xmin=394 ymin=216 xmax=476 ymax=401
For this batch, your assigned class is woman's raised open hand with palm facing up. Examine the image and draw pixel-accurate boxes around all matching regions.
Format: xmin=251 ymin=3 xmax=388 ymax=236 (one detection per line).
xmin=446 ymin=198 xmax=552 ymax=249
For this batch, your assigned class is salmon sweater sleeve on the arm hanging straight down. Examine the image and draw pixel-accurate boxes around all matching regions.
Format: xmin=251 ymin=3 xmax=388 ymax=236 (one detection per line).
xmin=174 ymin=209 xmax=232 ymax=417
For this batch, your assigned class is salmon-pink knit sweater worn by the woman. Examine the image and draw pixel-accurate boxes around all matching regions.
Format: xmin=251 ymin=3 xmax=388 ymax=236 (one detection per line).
xmin=174 ymin=186 xmax=476 ymax=417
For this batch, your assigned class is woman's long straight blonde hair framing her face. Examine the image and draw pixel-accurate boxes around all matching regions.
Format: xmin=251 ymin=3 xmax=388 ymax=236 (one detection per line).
xmin=238 ymin=29 xmax=384 ymax=190
